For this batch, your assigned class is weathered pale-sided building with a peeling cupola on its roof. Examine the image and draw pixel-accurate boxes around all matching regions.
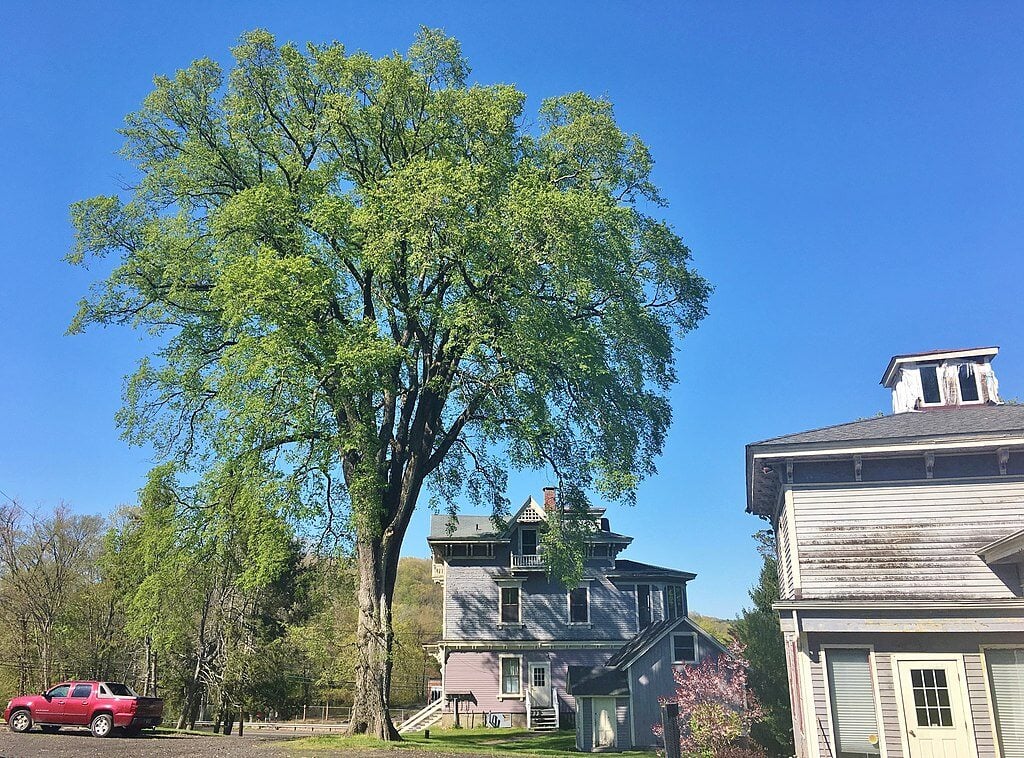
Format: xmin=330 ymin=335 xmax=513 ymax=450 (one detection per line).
xmin=746 ymin=347 xmax=1024 ymax=758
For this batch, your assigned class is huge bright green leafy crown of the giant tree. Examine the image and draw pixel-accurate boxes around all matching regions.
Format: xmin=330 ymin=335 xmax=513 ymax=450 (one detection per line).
xmin=69 ymin=29 xmax=710 ymax=561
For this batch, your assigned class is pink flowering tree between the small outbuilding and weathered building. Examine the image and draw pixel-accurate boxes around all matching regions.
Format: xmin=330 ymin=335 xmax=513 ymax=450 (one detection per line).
xmin=654 ymin=641 xmax=763 ymax=758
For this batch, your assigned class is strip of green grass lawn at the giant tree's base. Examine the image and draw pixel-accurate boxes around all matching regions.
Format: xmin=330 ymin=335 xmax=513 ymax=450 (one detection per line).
xmin=288 ymin=728 xmax=654 ymax=758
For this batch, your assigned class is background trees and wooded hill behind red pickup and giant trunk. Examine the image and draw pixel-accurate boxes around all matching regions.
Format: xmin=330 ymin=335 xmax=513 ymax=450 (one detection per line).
xmin=0 ymin=493 xmax=441 ymax=726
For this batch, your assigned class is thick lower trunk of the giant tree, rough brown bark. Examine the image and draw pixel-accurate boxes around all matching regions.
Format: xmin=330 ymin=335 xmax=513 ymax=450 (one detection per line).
xmin=348 ymin=539 xmax=401 ymax=741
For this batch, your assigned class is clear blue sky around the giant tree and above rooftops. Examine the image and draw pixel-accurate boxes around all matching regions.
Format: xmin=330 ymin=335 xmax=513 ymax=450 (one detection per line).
xmin=0 ymin=0 xmax=1024 ymax=616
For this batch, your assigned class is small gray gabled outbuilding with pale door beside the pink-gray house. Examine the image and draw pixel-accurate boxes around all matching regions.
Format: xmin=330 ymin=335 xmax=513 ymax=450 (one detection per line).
xmin=567 ymin=617 xmax=726 ymax=753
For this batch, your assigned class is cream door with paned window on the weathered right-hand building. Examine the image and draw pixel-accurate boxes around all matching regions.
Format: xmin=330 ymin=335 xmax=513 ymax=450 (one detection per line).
xmin=898 ymin=659 xmax=975 ymax=758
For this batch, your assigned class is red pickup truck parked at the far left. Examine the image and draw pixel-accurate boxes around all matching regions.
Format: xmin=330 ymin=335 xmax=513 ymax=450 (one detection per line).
xmin=3 ymin=681 xmax=164 ymax=736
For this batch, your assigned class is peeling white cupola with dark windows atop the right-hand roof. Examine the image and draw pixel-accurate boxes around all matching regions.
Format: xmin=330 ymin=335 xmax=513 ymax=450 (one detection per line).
xmin=882 ymin=347 xmax=1000 ymax=413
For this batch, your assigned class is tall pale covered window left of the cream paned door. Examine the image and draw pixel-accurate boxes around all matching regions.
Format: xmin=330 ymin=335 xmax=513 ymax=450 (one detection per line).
xmin=825 ymin=648 xmax=879 ymax=755
